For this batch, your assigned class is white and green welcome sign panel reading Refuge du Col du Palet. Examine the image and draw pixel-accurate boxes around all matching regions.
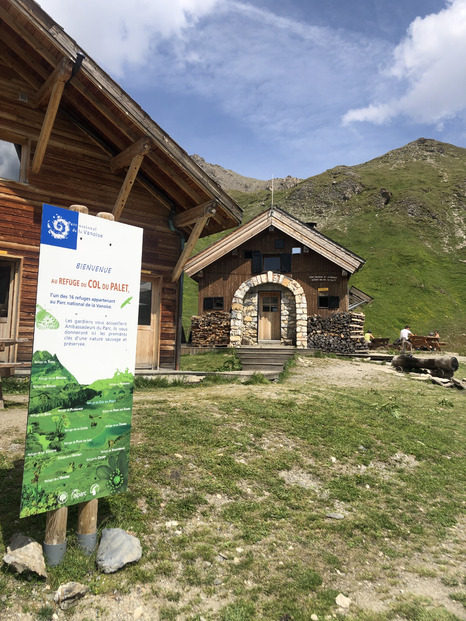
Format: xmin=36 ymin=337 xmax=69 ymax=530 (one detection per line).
xmin=20 ymin=205 xmax=142 ymax=517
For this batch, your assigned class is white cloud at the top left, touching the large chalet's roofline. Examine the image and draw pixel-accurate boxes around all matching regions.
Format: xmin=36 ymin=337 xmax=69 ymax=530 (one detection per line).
xmin=39 ymin=0 xmax=219 ymax=77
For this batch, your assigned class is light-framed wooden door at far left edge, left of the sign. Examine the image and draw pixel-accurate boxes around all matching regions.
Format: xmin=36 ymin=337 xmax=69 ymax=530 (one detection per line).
xmin=0 ymin=259 xmax=20 ymax=362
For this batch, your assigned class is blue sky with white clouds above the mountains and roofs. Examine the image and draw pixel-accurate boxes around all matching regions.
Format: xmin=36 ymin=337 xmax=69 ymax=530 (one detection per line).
xmin=34 ymin=0 xmax=466 ymax=179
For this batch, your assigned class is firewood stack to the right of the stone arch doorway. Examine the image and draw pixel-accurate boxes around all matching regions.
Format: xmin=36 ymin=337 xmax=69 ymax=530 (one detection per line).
xmin=307 ymin=313 xmax=367 ymax=354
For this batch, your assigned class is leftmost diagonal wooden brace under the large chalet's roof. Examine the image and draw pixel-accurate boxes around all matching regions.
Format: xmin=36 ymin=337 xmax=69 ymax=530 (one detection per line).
xmin=31 ymin=58 xmax=73 ymax=174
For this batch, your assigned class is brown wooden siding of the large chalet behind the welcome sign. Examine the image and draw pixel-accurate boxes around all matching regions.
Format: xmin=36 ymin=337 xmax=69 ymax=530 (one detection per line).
xmin=0 ymin=70 xmax=181 ymax=366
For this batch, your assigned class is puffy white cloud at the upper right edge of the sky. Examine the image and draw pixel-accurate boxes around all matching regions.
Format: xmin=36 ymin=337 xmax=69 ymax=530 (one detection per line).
xmin=343 ymin=0 xmax=466 ymax=127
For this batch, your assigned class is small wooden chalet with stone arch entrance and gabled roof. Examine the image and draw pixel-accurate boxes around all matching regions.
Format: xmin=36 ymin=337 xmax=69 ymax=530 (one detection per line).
xmin=185 ymin=207 xmax=365 ymax=348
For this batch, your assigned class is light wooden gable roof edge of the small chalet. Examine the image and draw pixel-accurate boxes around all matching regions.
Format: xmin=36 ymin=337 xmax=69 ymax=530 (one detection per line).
xmin=185 ymin=207 xmax=365 ymax=277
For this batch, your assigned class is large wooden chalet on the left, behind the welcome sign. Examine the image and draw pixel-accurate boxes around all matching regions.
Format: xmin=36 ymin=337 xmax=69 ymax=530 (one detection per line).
xmin=0 ymin=0 xmax=242 ymax=368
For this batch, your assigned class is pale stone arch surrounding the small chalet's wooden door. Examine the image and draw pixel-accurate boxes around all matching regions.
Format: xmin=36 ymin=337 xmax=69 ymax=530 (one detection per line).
xmin=230 ymin=272 xmax=307 ymax=349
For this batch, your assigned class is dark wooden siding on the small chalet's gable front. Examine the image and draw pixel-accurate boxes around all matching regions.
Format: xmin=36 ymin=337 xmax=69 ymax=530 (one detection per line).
xmin=196 ymin=230 xmax=348 ymax=317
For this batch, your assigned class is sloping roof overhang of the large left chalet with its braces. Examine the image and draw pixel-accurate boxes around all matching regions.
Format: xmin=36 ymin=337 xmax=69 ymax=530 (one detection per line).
xmin=0 ymin=0 xmax=242 ymax=280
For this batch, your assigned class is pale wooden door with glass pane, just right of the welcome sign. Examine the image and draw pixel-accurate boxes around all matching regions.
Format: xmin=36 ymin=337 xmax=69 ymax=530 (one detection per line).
xmin=136 ymin=274 xmax=162 ymax=369
